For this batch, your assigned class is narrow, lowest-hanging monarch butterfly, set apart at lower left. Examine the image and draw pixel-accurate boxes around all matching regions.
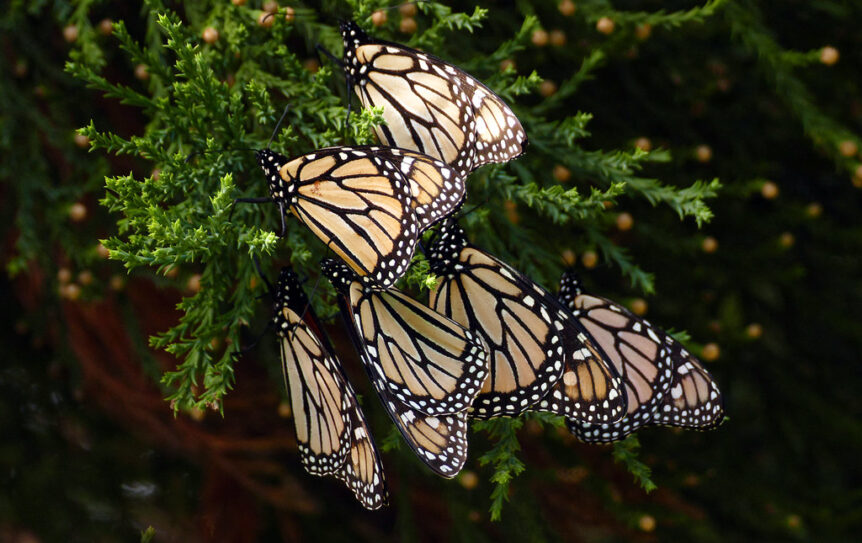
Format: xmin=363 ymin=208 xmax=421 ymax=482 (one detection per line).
xmin=274 ymin=268 xmax=388 ymax=509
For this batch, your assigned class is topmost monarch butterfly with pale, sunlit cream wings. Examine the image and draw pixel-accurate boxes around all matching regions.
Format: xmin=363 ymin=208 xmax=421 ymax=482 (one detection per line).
xmin=341 ymin=21 xmax=527 ymax=176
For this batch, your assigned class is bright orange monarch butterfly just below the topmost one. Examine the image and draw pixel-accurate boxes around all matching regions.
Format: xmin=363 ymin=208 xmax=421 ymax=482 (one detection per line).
xmin=255 ymin=147 xmax=464 ymax=287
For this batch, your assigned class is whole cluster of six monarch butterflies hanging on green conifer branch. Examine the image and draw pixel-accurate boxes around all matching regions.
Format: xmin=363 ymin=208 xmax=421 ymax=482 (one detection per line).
xmin=243 ymin=19 xmax=723 ymax=509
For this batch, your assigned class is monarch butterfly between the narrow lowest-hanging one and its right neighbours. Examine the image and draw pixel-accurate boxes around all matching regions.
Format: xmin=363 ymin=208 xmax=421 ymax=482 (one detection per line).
xmin=321 ymin=259 xmax=488 ymax=477
